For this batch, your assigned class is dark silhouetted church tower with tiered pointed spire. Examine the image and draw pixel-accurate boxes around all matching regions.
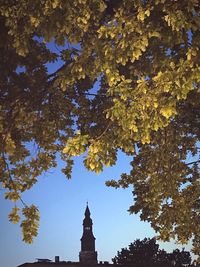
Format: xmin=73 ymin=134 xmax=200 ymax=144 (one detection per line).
xmin=79 ymin=204 xmax=97 ymax=264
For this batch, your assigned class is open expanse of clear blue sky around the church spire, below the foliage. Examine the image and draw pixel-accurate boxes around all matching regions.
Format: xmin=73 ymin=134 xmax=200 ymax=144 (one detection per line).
xmin=0 ymin=153 xmax=194 ymax=267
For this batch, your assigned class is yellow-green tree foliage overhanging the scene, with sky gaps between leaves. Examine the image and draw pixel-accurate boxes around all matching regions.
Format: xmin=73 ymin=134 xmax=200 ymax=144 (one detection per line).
xmin=0 ymin=0 xmax=200 ymax=260
